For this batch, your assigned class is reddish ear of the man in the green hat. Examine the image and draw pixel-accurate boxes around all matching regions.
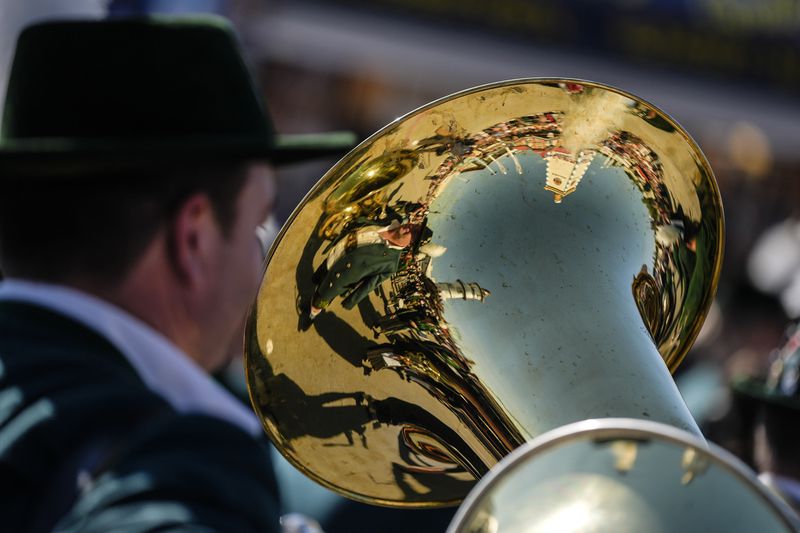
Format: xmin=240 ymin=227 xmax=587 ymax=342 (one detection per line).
xmin=168 ymin=193 xmax=220 ymax=286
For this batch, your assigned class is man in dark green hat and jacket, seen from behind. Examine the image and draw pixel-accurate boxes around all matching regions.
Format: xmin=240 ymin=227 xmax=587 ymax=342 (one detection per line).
xmin=0 ymin=14 xmax=352 ymax=531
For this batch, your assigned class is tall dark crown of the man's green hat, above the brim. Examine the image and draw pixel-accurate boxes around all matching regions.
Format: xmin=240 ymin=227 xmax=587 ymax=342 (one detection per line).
xmin=0 ymin=17 xmax=272 ymax=143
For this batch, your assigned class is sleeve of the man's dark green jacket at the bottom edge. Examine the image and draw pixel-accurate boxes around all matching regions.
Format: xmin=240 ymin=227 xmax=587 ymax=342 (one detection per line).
xmin=58 ymin=413 xmax=279 ymax=531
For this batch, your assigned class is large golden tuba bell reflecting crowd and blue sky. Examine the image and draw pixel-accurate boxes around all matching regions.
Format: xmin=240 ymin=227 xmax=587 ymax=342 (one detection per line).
xmin=245 ymin=80 xmax=723 ymax=507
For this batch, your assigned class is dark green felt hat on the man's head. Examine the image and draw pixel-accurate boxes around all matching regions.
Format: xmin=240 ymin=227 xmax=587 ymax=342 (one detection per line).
xmin=0 ymin=16 xmax=355 ymax=175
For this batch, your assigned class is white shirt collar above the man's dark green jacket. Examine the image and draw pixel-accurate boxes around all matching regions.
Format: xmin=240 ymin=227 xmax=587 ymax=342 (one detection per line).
xmin=0 ymin=279 xmax=263 ymax=436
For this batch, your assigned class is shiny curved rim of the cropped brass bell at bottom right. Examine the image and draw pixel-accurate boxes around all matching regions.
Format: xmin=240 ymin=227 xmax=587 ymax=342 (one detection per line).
xmin=447 ymin=418 xmax=800 ymax=533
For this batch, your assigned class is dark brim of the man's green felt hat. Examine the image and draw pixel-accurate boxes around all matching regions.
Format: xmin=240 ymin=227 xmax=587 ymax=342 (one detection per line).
xmin=0 ymin=132 xmax=357 ymax=180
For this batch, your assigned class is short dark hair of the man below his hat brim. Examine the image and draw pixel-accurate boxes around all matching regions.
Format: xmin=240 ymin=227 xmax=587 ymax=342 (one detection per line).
xmin=0 ymin=163 xmax=246 ymax=286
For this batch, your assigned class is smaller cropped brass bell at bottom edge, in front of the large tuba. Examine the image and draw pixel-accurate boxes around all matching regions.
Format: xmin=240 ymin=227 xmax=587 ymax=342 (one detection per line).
xmin=447 ymin=419 xmax=800 ymax=533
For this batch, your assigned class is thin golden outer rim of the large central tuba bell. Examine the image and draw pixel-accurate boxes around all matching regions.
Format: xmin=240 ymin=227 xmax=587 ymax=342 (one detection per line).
xmin=245 ymin=78 xmax=724 ymax=508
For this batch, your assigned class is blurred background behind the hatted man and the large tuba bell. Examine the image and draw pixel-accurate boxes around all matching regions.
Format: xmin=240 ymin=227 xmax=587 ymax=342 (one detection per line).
xmin=0 ymin=0 xmax=800 ymax=528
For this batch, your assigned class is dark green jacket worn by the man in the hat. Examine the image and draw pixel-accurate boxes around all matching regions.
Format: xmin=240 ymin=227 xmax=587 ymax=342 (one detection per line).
xmin=0 ymin=302 xmax=279 ymax=532
